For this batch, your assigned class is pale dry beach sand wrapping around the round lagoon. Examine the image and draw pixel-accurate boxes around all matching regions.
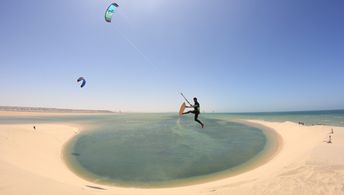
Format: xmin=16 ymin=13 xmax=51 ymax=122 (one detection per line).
xmin=0 ymin=115 xmax=344 ymax=195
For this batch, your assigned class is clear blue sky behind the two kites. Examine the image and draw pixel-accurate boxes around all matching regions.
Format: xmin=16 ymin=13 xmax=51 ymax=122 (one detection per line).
xmin=0 ymin=0 xmax=344 ymax=112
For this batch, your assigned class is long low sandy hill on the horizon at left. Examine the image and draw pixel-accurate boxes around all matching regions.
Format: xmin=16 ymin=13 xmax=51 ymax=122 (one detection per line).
xmin=0 ymin=106 xmax=113 ymax=113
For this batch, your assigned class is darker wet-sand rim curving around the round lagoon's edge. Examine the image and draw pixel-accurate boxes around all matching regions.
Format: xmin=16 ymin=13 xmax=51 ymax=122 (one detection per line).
xmin=62 ymin=120 xmax=283 ymax=189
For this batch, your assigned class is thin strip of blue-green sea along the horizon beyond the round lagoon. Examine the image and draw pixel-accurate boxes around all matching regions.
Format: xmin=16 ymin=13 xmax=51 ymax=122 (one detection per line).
xmin=0 ymin=110 xmax=344 ymax=127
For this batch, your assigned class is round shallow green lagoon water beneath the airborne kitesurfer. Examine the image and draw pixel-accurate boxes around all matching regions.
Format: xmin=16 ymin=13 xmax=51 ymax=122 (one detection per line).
xmin=65 ymin=114 xmax=267 ymax=187
